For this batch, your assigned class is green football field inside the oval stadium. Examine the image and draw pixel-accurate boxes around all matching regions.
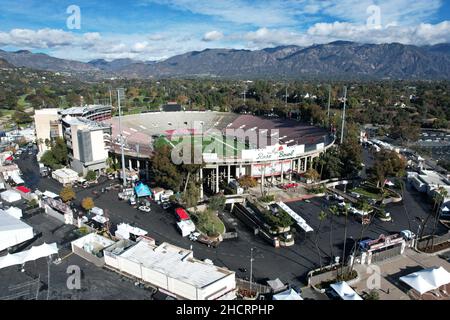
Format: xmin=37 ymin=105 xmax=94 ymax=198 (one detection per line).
xmin=155 ymin=135 xmax=250 ymax=157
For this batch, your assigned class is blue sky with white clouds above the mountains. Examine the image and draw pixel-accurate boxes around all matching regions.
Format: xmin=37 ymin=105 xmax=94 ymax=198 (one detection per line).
xmin=0 ymin=0 xmax=450 ymax=61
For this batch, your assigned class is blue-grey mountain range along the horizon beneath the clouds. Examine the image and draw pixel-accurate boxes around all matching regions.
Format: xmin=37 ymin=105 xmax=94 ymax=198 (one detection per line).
xmin=0 ymin=41 xmax=450 ymax=80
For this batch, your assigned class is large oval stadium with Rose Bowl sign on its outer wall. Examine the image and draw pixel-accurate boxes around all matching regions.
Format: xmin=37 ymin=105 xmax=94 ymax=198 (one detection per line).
xmin=107 ymin=111 xmax=335 ymax=193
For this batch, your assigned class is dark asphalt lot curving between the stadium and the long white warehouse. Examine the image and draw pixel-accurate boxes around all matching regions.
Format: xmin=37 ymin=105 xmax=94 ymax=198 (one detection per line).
xmin=9 ymin=152 xmax=446 ymax=286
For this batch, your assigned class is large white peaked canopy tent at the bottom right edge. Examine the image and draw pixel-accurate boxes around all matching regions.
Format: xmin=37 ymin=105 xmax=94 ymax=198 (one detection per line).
xmin=400 ymin=267 xmax=450 ymax=294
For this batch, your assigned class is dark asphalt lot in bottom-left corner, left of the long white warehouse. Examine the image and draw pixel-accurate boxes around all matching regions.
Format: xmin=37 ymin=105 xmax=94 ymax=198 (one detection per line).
xmin=0 ymin=214 xmax=153 ymax=300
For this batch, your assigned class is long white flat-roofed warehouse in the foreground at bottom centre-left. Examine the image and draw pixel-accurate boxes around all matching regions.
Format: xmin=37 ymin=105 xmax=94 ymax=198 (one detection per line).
xmin=104 ymin=239 xmax=236 ymax=300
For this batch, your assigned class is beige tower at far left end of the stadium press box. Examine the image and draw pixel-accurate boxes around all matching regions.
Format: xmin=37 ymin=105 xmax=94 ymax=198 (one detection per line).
xmin=34 ymin=109 xmax=62 ymax=160
